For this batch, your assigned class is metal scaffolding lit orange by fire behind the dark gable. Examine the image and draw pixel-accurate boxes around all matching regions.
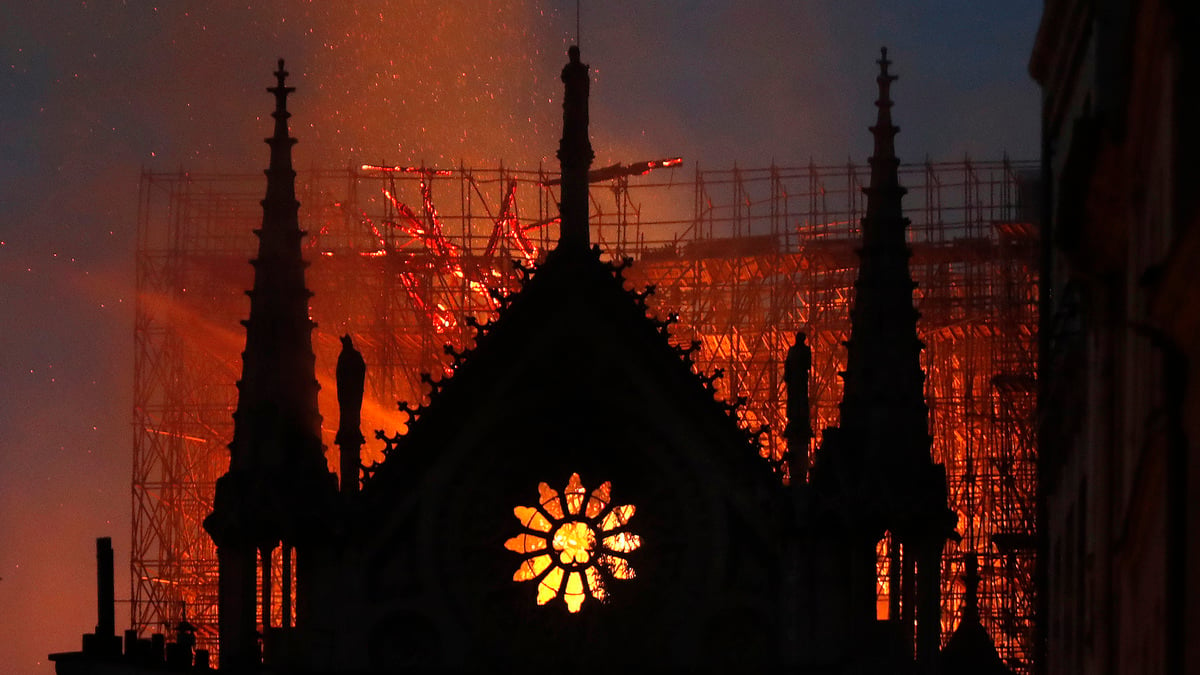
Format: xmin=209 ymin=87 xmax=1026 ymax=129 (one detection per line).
xmin=131 ymin=160 xmax=1038 ymax=673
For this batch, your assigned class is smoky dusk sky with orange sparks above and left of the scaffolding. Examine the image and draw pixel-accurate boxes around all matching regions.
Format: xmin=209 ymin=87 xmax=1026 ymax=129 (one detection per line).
xmin=0 ymin=0 xmax=1042 ymax=675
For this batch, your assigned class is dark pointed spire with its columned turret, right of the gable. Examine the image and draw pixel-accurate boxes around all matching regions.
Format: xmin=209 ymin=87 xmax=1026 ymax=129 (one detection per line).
xmin=810 ymin=49 xmax=955 ymax=673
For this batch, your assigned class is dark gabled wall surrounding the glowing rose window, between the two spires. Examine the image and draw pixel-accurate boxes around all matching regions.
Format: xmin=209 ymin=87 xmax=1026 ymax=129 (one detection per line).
xmin=354 ymin=246 xmax=778 ymax=663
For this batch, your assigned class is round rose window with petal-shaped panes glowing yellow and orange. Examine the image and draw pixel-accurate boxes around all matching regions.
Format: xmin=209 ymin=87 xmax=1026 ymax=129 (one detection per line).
xmin=504 ymin=473 xmax=642 ymax=613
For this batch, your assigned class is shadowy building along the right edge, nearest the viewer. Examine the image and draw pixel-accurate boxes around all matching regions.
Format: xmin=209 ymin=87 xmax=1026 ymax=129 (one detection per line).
xmin=1031 ymin=0 xmax=1200 ymax=674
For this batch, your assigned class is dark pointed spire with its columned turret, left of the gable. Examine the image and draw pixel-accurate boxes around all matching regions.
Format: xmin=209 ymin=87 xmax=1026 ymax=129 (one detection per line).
xmin=204 ymin=59 xmax=334 ymax=671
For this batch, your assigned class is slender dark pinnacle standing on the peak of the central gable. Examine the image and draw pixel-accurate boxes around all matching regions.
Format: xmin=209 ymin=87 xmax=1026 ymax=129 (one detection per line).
xmin=558 ymin=44 xmax=595 ymax=250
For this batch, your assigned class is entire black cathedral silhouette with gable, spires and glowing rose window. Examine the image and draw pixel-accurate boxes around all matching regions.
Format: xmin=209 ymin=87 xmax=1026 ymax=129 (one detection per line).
xmin=60 ymin=47 xmax=1004 ymax=675
